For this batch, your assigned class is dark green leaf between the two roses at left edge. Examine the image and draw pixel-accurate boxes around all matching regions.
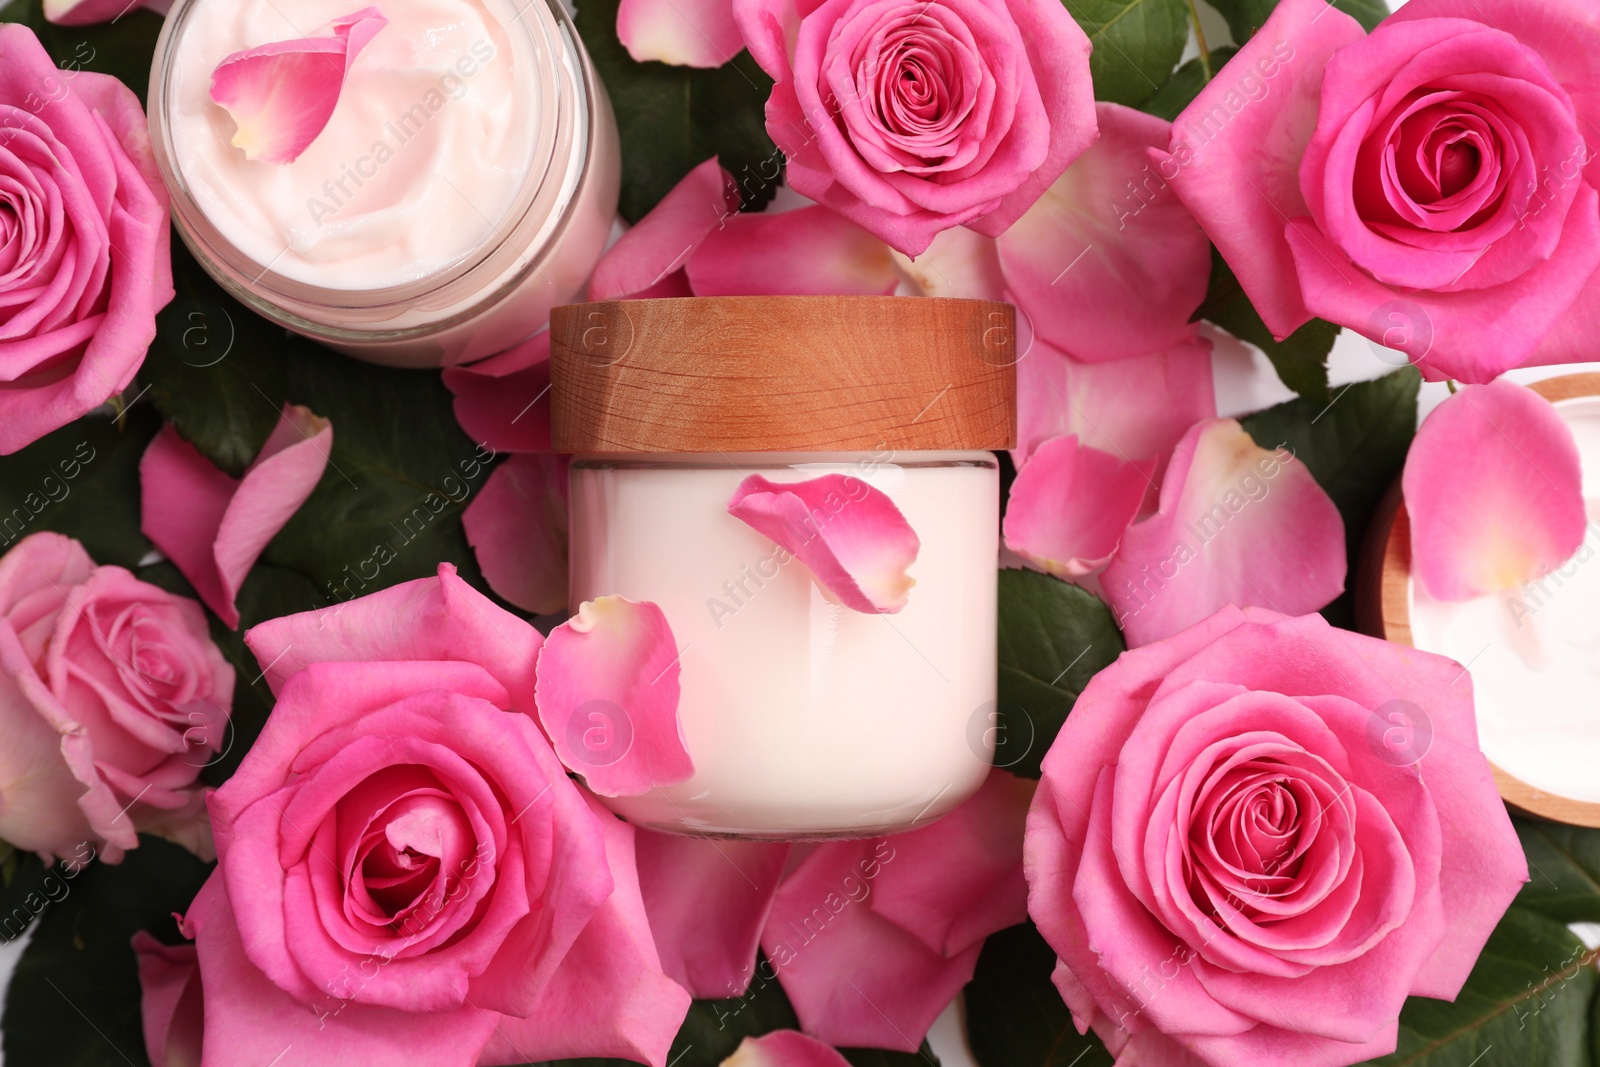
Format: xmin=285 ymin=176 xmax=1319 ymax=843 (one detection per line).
xmin=0 ymin=398 xmax=160 ymax=568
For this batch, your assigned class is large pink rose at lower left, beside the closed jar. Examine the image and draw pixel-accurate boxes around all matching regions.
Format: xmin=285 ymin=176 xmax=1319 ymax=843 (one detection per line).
xmin=187 ymin=565 xmax=690 ymax=1067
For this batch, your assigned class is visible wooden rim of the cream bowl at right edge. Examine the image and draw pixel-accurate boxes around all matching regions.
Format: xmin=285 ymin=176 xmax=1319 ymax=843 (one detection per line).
xmin=1357 ymin=374 xmax=1600 ymax=829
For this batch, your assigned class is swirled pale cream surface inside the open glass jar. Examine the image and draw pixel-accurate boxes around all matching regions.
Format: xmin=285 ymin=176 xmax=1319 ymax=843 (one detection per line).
xmin=168 ymin=0 xmax=541 ymax=291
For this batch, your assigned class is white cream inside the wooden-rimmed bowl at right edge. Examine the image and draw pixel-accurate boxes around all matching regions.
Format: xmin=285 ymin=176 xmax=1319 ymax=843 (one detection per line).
xmin=1410 ymin=397 xmax=1600 ymax=801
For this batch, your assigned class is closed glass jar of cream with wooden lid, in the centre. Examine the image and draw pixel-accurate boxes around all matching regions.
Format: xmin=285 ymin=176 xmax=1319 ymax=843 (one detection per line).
xmin=550 ymin=296 xmax=1016 ymax=838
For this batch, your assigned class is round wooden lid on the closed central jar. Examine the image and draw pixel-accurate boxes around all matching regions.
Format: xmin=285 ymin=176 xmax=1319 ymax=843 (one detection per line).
xmin=550 ymin=296 xmax=1016 ymax=453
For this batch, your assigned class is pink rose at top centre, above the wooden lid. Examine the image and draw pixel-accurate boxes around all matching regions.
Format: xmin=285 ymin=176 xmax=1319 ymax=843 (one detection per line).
xmin=733 ymin=0 xmax=1096 ymax=256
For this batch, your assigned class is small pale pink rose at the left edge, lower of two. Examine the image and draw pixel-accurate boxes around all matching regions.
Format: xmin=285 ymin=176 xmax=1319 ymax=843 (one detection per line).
xmin=0 ymin=533 xmax=234 ymax=862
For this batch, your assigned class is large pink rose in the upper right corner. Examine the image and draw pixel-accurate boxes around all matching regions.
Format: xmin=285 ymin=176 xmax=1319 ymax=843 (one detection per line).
xmin=1157 ymin=0 xmax=1600 ymax=382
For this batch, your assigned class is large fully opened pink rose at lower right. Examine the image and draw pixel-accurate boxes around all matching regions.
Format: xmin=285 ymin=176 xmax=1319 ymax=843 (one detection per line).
xmin=1024 ymin=608 xmax=1528 ymax=1067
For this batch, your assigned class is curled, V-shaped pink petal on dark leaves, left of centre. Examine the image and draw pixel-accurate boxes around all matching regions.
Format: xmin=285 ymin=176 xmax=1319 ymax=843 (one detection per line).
xmin=139 ymin=405 xmax=333 ymax=630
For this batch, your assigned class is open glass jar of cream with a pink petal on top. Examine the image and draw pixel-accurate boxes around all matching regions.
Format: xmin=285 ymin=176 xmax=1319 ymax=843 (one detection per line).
xmin=149 ymin=0 xmax=621 ymax=366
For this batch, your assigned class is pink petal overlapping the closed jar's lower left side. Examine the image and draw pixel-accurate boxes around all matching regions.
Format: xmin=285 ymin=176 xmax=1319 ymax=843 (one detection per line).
xmin=534 ymin=597 xmax=694 ymax=797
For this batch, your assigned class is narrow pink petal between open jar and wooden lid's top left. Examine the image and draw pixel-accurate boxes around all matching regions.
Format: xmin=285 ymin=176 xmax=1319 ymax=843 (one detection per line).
xmin=589 ymin=155 xmax=739 ymax=301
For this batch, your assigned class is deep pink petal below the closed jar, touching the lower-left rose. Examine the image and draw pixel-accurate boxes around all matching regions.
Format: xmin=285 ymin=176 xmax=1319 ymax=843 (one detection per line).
xmin=635 ymin=829 xmax=789 ymax=1000
